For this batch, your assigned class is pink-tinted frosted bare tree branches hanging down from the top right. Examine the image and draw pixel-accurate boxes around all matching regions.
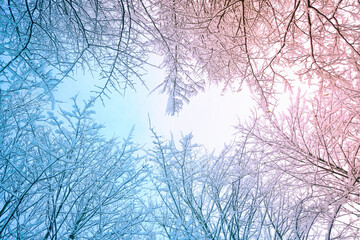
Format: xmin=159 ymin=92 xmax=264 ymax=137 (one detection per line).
xmin=151 ymin=0 xmax=360 ymax=109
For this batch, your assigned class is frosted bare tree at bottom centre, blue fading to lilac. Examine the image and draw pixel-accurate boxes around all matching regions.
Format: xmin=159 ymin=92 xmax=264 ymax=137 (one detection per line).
xmin=151 ymin=128 xmax=317 ymax=239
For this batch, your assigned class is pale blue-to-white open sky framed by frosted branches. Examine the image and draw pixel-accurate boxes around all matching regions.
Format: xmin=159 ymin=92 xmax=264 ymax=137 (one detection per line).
xmin=55 ymin=55 xmax=253 ymax=151
